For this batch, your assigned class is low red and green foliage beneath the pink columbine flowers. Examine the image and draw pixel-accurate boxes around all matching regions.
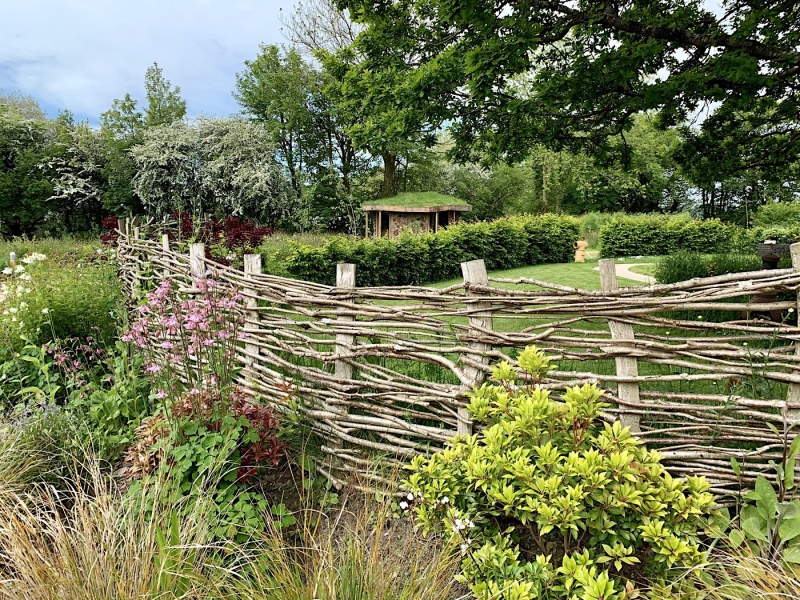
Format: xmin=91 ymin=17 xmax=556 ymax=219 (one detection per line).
xmin=125 ymin=389 xmax=293 ymax=541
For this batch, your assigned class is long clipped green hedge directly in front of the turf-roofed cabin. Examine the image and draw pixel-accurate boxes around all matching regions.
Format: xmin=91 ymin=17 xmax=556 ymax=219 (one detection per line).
xmin=278 ymin=215 xmax=579 ymax=286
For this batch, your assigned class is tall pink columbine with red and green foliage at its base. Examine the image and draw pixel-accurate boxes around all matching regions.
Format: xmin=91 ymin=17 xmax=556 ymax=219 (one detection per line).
xmin=122 ymin=272 xmax=284 ymax=540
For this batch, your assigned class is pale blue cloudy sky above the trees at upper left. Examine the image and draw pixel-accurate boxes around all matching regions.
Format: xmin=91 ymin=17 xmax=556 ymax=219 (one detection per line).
xmin=0 ymin=0 xmax=293 ymax=122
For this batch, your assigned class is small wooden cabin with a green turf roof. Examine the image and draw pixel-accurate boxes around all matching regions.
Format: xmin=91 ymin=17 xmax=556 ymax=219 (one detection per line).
xmin=361 ymin=192 xmax=472 ymax=239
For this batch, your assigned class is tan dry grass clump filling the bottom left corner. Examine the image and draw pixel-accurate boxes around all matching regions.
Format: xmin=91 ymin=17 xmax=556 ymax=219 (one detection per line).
xmin=0 ymin=457 xmax=219 ymax=600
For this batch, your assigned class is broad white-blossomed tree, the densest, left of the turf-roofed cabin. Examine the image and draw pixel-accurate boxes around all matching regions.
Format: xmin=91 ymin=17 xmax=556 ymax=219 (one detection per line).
xmin=130 ymin=119 xmax=299 ymax=226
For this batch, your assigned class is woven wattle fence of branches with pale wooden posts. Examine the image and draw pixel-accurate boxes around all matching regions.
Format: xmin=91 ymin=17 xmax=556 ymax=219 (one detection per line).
xmin=119 ymin=223 xmax=800 ymax=496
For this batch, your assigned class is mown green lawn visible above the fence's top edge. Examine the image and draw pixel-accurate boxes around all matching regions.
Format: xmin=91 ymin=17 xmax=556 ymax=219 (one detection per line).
xmin=431 ymin=256 xmax=657 ymax=290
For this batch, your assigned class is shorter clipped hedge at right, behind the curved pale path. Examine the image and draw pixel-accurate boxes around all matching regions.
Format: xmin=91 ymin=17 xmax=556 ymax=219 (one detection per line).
xmin=599 ymin=214 xmax=740 ymax=258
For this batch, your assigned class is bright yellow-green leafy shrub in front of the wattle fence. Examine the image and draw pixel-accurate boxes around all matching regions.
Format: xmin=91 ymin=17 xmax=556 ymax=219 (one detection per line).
xmin=401 ymin=347 xmax=714 ymax=600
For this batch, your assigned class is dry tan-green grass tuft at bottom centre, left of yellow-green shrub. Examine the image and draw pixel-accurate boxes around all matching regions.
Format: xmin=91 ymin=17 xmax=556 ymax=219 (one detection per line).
xmin=203 ymin=492 xmax=465 ymax=600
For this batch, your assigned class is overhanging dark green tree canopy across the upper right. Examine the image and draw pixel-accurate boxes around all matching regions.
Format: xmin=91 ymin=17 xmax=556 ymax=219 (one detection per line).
xmin=337 ymin=0 xmax=800 ymax=173
